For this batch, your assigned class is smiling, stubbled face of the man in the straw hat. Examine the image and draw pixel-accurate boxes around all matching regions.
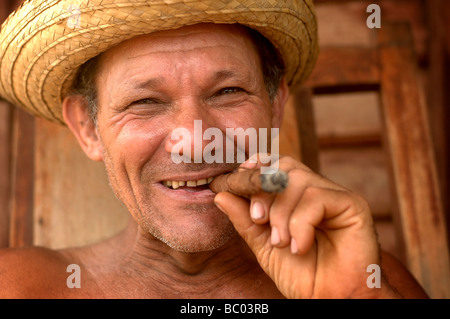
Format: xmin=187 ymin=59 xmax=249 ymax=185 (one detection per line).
xmin=93 ymin=24 xmax=278 ymax=252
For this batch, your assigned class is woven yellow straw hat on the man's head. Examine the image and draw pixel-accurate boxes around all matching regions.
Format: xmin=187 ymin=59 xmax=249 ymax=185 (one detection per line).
xmin=0 ymin=0 xmax=318 ymax=123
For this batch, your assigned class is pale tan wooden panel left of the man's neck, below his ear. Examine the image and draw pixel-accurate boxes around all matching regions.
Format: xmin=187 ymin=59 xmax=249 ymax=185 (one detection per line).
xmin=34 ymin=119 xmax=129 ymax=249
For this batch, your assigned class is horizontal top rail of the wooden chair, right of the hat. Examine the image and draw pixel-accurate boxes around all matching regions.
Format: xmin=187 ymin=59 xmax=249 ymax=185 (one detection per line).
xmin=306 ymin=47 xmax=380 ymax=91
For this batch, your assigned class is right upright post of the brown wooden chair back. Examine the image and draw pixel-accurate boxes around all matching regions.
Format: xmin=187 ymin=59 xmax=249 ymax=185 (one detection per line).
xmin=379 ymin=24 xmax=450 ymax=298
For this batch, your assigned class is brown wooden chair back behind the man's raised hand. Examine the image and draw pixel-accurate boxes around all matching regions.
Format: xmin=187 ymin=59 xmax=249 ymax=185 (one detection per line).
xmin=294 ymin=23 xmax=450 ymax=298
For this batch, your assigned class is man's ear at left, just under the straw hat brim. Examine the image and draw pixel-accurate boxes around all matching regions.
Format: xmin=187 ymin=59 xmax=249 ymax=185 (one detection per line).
xmin=62 ymin=95 xmax=103 ymax=161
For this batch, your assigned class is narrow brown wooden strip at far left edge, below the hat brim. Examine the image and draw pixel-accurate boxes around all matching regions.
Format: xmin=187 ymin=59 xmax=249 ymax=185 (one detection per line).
xmin=0 ymin=101 xmax=11 ymax=247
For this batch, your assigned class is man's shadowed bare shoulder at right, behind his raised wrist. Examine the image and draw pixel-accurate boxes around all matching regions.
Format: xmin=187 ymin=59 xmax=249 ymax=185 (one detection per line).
xmin=381 ymin=251 xmax=429 ymax=299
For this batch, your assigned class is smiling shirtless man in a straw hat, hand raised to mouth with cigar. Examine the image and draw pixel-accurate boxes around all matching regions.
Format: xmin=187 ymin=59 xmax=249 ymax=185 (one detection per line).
xmin=0 ymin=1 xmax=425 ymax=298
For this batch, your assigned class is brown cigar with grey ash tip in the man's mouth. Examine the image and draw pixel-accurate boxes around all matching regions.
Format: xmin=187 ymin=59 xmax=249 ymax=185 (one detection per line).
xmin=209 ymin=168 xmax=289 ymax=196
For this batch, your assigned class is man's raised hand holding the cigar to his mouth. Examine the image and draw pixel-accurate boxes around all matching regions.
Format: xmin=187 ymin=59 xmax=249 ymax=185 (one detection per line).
xmin=215 ymin=157 xmax=396 ymax=298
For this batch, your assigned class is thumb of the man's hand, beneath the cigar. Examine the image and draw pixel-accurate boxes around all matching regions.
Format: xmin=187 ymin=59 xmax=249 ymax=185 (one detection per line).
xmin=214 ymin=192 xmax=270 ymax=254
